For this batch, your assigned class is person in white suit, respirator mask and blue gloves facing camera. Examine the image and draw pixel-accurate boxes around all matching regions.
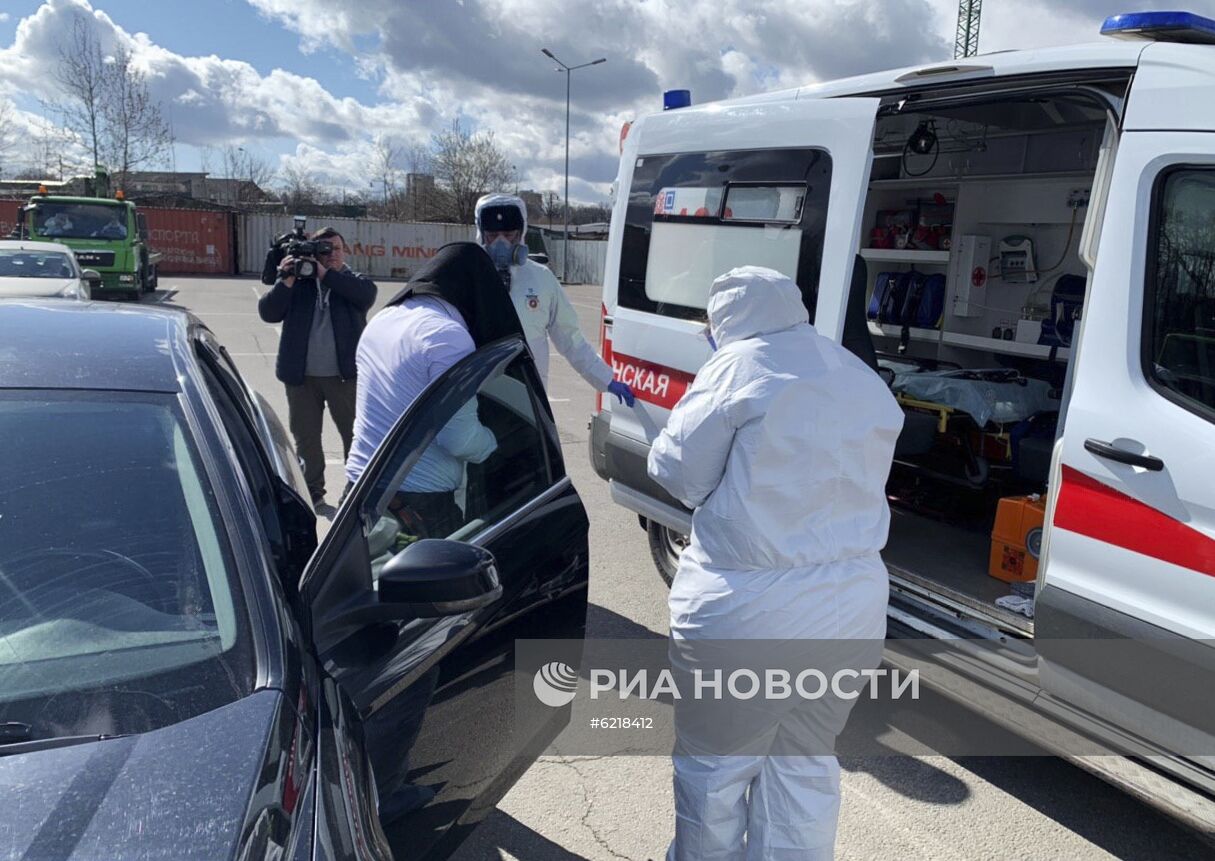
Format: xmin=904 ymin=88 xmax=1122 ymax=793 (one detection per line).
xmin=476 ymin=194 xmax=633 ymax=407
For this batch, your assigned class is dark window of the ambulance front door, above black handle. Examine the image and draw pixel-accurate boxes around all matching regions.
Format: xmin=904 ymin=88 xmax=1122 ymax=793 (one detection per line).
xmin=1143 ymin=168 xmax=1215 ymax=421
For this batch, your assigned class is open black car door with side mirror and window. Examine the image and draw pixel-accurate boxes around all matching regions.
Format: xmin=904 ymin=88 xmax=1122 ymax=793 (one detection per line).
xmin=300 ymin=339 xmax=588 ymax=859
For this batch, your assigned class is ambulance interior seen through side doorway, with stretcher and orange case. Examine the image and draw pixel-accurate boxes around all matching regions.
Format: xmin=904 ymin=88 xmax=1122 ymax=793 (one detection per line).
xmin=851 ymin=83 xmax=1111 ymax=634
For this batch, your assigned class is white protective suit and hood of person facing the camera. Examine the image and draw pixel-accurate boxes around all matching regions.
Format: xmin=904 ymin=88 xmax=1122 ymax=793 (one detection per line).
xmin=476 ymin=194 xmax=612 ymax=391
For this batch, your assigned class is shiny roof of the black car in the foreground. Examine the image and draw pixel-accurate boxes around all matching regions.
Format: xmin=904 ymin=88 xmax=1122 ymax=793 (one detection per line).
xmin=0 ymin=299 xmax=198 ymax=392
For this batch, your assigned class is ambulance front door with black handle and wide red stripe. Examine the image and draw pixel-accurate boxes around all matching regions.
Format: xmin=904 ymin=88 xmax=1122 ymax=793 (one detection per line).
xmin=1034 ymin=98 xmax=1215 ymax=757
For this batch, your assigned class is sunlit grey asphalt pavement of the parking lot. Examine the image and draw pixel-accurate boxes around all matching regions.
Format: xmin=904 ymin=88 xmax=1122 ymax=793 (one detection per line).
xmin=143 ymin=276 xmax=1215 ymax=861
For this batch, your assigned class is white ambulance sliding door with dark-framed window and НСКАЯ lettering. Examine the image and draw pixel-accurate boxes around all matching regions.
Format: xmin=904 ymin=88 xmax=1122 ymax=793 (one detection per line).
xmin=604 ymin=98 xmax=878 ymax=443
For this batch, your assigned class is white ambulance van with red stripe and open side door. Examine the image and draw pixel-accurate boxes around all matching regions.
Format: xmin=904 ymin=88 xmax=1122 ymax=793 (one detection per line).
xmin=590 ymin=12 xmax=1215 ymax=833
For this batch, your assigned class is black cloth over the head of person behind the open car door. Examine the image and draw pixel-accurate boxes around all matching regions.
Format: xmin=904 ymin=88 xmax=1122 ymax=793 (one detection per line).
xmin=389 ymin=242 xmax=524 ymax=347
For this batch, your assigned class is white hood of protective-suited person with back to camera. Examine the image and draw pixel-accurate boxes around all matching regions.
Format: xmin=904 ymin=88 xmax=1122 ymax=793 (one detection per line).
xmin=708 ymin=266 xmax=810 ymax=347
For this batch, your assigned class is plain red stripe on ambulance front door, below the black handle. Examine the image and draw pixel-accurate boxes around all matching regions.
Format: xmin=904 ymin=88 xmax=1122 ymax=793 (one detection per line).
xmin=1055 ymin=466 xmax=1215 ymax=577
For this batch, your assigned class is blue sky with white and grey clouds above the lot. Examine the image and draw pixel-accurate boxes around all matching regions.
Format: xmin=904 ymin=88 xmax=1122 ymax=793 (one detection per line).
xmin=0 ymin=0 xmax=1215 ymax=203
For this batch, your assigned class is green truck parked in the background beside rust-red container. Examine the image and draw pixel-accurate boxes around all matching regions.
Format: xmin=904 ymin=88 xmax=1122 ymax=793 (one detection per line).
xmin=21 ymin=191 xmax=160 ymax=299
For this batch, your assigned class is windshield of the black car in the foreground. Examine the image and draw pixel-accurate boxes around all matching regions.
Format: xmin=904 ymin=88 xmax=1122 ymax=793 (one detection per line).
xmin=0 ymin=391 xmax=254 ymax=738
